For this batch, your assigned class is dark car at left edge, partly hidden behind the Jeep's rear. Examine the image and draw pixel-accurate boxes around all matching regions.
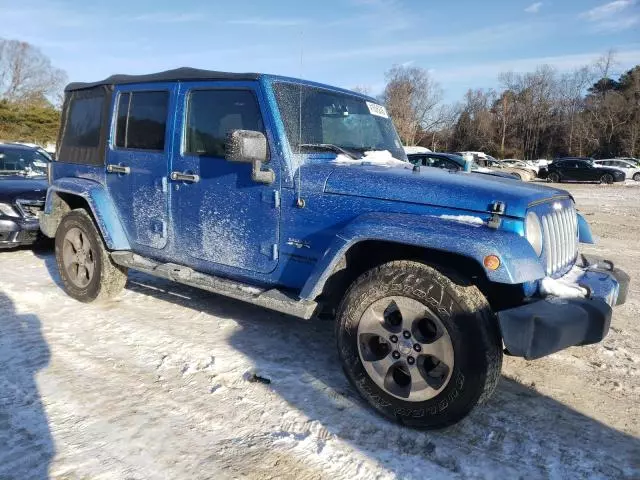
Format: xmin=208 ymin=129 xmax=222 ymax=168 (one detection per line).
xmin=0 ymin=144 xmax=49 ymax=248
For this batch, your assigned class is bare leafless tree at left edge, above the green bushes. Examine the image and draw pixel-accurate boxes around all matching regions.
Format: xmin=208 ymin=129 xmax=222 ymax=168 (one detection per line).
xmin=0 ymin=38 xmax=66 ymax=103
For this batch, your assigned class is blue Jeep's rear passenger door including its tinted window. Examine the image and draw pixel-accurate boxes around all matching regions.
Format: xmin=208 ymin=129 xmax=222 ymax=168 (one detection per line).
xmin=106 ymin=84 xmax=176 ymax=250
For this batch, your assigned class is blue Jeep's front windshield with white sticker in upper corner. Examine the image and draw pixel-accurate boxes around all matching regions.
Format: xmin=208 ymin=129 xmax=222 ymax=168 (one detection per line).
xmin=274 ymin=82 xmax=407 ymax=165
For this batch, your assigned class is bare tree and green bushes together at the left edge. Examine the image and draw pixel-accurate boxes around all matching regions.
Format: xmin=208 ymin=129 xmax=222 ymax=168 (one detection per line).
xmin=0 ymin=38 xmax=66 ymax=145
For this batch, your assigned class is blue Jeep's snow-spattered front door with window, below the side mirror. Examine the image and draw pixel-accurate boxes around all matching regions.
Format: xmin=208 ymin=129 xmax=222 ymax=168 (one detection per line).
xmin=170 ymin=82 xmax=280 ymax=273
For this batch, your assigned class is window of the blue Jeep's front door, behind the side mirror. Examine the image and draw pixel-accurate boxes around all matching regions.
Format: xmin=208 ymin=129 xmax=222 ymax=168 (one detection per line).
xmin=185 ymin=90 xmax=264 ymax=157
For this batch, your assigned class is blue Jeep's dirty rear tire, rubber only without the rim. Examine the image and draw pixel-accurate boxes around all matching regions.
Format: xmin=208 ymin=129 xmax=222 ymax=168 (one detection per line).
xmin=55 ymin=208 xmax=127 ymax=303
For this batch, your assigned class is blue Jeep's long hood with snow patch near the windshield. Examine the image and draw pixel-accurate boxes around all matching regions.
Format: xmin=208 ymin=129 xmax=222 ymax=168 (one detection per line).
xmin=324 ymin=165 xmax=570 ymax=218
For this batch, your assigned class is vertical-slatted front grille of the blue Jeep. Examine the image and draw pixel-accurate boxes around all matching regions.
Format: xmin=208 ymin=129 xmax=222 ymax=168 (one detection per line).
xmin=542 ymin=203 xmax=578 ymax=275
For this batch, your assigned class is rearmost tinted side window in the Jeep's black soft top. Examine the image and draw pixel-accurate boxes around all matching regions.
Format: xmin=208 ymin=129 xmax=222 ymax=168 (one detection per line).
xmin=62 ymin=96 xmax=104 ymax=148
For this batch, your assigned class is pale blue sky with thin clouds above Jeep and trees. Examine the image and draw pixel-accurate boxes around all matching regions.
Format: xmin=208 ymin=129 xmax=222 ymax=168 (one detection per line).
xmin=0 ymin=0 xmax=640 ymax=101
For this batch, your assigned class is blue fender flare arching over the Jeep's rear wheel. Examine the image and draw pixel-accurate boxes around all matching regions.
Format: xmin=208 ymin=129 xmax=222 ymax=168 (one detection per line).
xmin=40 ymin=178 xmax=131 ymax=250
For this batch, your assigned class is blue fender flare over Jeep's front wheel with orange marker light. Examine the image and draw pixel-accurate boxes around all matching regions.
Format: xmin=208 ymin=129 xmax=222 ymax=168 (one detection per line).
xmin=300 ymin=213 xmax=545 ymax=299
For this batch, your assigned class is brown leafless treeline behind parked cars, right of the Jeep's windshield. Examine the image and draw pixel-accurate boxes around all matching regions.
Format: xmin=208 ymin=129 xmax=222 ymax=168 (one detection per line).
xmin=382 ymin=53 xmax=640 ymax=159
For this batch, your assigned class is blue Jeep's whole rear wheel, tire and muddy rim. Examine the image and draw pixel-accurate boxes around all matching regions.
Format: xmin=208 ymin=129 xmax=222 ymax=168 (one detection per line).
xmin=55 ymin=209 xmax=127 ymax=303
